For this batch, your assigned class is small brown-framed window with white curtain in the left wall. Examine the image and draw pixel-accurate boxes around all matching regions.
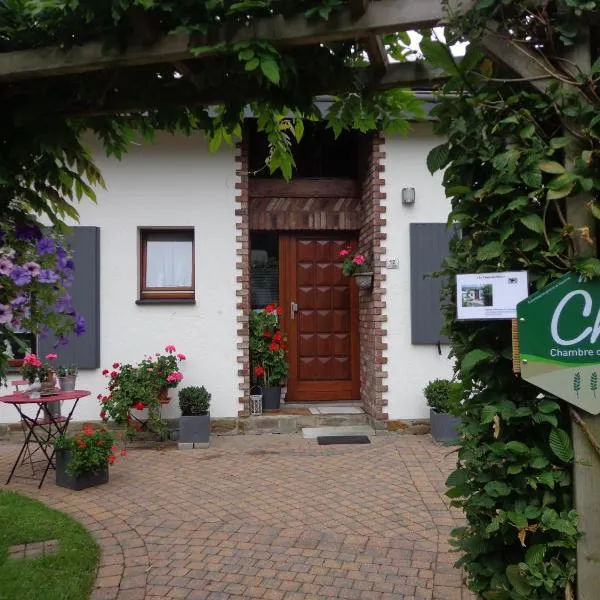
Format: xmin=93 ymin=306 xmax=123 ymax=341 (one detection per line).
xmin=140 ymin=229 xmax=194 ymax=300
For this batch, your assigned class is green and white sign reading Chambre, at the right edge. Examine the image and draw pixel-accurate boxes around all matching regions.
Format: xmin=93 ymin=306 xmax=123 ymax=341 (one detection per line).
xmin=517 ymin=274 xmax=600 ymax=415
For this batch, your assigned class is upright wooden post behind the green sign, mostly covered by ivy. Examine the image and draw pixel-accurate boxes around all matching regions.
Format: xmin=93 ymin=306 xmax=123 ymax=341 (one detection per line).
xmin=565 ymin=27 xmax=600 ymax=600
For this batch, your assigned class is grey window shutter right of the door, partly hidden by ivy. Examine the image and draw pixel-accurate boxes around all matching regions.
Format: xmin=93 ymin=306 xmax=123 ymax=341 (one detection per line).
xmin=410 ymin=223 xmax=454 ymax=344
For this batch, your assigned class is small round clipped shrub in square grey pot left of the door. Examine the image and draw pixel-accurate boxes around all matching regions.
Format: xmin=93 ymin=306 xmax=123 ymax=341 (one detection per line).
xmin=179 ymin=386 xmax=211 ymax=449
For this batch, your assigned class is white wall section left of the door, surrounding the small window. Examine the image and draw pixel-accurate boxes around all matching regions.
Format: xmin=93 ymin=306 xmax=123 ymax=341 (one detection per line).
xmin=0 ymin=134 xmax=240 ymax=423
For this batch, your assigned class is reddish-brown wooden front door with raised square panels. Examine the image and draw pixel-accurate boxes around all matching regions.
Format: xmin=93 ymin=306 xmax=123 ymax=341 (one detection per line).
xmin=279 ymin=233 xmax=360 ymax=402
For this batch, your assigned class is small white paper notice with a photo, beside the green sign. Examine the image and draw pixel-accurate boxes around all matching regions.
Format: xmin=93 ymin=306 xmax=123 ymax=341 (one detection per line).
xmin=456 ymin=271 xmax=528 ymax=320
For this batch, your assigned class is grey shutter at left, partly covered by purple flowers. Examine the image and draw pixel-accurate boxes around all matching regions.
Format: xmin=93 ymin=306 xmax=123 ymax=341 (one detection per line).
xmin=38 ymin=227 xmax=100 ymax=369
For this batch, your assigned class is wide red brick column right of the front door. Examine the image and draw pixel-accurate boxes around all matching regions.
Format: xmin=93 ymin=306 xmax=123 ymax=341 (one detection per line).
xmin=359 ymin=132 xmax=388 ymax=420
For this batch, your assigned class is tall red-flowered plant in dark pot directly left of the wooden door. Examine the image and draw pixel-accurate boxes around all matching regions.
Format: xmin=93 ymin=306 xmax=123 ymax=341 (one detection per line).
xmin=250 ymin=304 xmax=289 ymax=411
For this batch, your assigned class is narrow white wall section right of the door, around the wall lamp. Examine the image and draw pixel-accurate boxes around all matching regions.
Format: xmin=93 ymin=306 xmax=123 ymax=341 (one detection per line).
xmin=382 ymin=123 xmax=452 ymax=419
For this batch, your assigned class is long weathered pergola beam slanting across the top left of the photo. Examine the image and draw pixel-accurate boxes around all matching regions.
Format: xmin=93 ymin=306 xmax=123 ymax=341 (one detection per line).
xmin=0 ymin=0 xmax=475 ymax=81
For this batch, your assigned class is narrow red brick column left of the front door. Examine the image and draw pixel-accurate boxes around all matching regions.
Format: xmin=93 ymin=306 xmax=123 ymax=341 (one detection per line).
xmin=235 ymin=141 xmax=250 ymax=416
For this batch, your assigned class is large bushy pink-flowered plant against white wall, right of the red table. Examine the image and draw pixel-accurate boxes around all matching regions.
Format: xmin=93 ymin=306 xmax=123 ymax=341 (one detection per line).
xmin=98 ymin=344 xmax=186 ymax=439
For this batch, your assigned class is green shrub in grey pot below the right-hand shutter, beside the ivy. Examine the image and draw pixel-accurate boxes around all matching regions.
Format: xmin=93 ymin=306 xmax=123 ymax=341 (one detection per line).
xmin=423 ymin=379 xmax=463 ymax=442
